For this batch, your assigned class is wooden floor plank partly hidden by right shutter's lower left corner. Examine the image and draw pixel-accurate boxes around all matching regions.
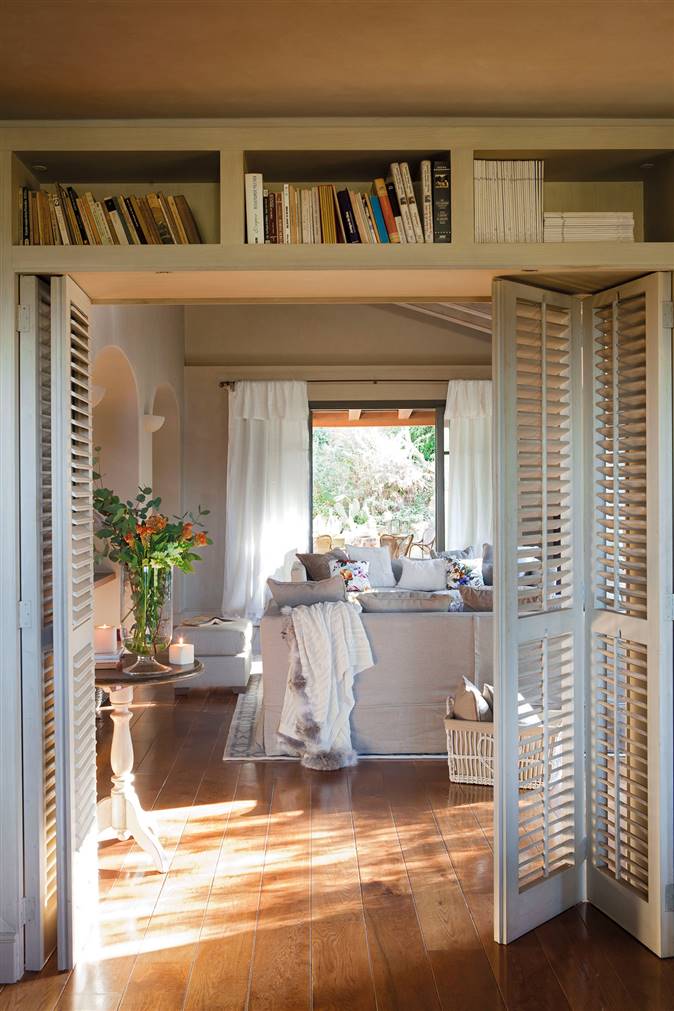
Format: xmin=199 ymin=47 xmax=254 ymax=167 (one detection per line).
xmin=422 ymin=763 xmax=570 ymax=1011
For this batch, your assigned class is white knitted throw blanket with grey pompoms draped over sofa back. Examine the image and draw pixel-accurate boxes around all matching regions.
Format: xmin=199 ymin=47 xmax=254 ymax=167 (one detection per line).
xmin=279 ymin=602 xmax=374 ymax=769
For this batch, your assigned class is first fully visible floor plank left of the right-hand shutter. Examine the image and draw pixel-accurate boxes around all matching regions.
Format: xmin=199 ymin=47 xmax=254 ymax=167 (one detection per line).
xmin=384 ymin=763 xmax=504 ymax=1011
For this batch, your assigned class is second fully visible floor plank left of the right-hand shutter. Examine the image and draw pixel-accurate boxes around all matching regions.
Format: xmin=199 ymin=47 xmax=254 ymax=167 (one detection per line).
xmin=351 ymin=761 xmax=441 ymax=1011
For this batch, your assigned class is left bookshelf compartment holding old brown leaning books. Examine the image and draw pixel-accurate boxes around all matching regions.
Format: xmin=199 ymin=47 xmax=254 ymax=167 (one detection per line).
xmin=12 ymin=151 xmax=220 ymax=246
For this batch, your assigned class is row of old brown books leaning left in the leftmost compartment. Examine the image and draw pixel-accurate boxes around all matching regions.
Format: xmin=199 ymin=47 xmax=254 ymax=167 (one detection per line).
xmin=19 ymin=183 xmax=201 ymax=246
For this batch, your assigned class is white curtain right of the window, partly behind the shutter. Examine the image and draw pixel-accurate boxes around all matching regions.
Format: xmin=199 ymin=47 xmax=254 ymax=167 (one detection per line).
xmin=445 ymin=379 xmax=493 ymax=553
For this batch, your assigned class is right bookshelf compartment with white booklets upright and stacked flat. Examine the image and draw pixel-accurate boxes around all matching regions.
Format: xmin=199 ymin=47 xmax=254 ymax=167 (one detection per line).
xmin=474 ymin=150 xmax=674 ymax=244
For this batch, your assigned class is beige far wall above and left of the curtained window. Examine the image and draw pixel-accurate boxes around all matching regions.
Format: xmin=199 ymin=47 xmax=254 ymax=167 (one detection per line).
xmin=183 ymin=304 xmax=491 ymax=614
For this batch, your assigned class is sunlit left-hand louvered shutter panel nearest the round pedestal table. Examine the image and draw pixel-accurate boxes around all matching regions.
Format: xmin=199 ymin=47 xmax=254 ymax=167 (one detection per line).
xmin=52 ymin=277 xmax=97 ymax=969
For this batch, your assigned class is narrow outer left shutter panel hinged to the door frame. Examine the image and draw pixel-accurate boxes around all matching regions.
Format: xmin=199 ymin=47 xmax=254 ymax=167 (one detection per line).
xmin=19 ymin=277 xmax=57 ymax=971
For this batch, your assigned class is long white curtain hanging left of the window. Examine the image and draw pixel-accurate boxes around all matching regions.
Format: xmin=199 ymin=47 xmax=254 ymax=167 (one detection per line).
xmin=222 ymin=381 xmax=309 ymax=621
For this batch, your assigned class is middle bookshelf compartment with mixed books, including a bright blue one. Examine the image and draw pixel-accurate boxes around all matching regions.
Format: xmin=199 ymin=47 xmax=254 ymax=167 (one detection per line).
xmin=244 ymin=149 xmax=451 ymax=247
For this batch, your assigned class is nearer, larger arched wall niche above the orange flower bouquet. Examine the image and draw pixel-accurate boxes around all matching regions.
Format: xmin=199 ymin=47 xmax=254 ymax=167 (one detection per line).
xmin=92 ymin=346 xmax=140 ymax=499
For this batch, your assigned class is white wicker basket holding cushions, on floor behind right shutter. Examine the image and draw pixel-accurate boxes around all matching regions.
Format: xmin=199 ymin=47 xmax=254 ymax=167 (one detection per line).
xmin=445 ymin=716 xmax=556 ymax=790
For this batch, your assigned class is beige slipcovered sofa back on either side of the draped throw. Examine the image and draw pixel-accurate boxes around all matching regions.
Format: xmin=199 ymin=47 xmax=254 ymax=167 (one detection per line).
xmin=260 ymin=602 xmax=493 ymax=755
